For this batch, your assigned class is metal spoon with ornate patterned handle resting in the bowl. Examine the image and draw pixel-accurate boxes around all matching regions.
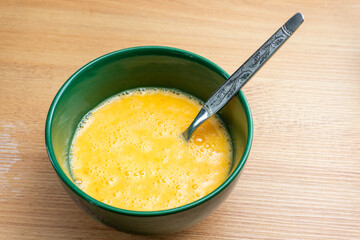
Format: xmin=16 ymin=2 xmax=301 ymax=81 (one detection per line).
xmin=182 ymin=13 xmax=304 ymax=141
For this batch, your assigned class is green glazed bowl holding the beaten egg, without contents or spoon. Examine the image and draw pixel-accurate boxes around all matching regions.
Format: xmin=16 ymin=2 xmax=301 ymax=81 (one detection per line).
xmin=45 ymin=46 xmax=253 ymax=234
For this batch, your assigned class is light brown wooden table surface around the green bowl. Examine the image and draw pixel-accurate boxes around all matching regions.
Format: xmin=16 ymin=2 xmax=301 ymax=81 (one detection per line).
xmin=0 ymin=0 xmax=360 ymax=240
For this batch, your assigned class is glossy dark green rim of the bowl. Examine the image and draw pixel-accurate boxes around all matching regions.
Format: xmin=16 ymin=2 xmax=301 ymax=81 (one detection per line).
xmin=45 ymin=46 xmax=253 ymax=217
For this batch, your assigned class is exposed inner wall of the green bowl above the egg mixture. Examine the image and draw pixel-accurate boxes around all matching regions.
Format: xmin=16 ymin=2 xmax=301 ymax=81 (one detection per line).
xmin=51 ymin=50 xmax=248 ymax=184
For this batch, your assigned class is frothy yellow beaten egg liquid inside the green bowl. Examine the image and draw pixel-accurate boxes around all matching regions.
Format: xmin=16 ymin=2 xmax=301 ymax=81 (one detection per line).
xmin=70 ymin=89 xmax=232 ymax=211
